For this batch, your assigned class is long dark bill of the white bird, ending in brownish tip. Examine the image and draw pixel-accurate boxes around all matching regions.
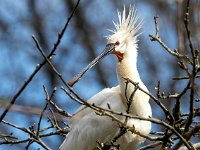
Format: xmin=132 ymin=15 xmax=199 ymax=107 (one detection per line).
xmin=68 ymin=44 xmax=115 ymax=87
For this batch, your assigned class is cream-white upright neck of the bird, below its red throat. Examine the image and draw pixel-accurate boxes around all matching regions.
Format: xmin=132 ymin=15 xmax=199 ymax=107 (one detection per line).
xmin=117 ymin=47 xmax=146 ymax=115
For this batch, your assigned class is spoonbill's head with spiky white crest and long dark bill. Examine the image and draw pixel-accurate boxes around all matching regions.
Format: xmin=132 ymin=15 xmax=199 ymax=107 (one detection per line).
xmin=68 ymin=6 xmax=142 ymax=86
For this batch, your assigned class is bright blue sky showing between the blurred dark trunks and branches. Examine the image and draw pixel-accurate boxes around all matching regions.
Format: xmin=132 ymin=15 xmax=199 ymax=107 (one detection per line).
xmin=0 ymin=0 xmax=197 ymax=149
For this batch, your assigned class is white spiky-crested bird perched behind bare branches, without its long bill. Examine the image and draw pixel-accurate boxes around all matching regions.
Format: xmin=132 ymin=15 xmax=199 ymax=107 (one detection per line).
xmin=60 ymin=6 xmax=152 ymax=150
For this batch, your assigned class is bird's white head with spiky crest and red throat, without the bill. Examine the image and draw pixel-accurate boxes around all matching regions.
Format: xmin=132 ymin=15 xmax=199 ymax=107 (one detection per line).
xmin=107 ymin=6 xmax=142 ymax=61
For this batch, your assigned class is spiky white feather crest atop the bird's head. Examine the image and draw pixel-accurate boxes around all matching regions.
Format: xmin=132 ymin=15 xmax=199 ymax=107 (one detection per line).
xmin=107 ymin=5 xmax=142 ymax=42
